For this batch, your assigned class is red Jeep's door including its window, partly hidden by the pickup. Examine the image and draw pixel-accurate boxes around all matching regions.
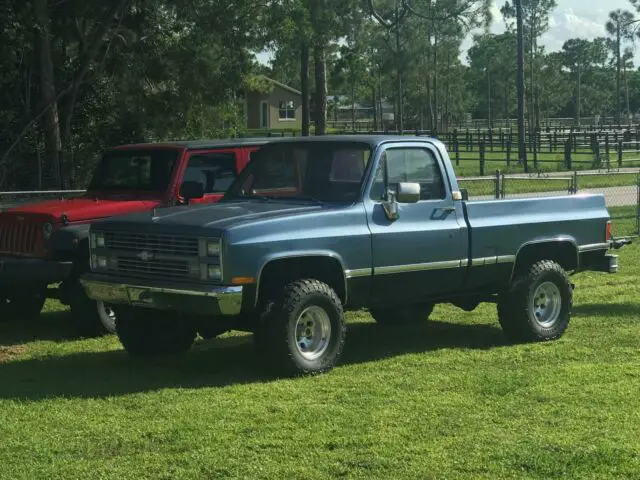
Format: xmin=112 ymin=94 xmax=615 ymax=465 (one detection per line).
xmin=182 ymin=149 xmax=241 ymax=203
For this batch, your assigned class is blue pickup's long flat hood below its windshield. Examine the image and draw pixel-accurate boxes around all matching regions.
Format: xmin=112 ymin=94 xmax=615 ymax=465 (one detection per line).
xmin=99 ymin=200 xmax=331 ymax=230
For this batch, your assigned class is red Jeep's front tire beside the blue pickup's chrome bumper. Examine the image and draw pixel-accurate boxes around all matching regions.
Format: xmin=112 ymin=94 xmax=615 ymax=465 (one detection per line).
xmin=69 ymin=282 xmax=116 ymax=337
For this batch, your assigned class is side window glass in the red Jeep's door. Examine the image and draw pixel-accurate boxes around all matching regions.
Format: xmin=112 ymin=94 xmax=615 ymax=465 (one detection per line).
xmin=183 ymin=153 xmax=237 ymax=194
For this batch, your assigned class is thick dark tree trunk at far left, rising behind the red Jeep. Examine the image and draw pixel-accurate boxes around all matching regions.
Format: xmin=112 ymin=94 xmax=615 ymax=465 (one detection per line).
xmin=33 ymin=0 xmax=63 ymax=188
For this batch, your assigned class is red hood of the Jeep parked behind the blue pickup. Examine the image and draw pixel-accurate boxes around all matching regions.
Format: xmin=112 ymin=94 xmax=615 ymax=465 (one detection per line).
xmin=5 ymin=197 xmax=160 ymax=223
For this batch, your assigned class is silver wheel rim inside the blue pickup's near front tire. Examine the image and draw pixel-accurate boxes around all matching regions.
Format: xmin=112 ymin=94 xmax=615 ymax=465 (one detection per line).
xmin=296 ymin=305 xmax=331 ymax=360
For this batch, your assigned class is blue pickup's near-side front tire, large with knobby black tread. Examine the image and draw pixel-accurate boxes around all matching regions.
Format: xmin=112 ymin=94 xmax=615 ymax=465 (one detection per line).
xmin=254 ymin=279 xmax=346 ymax=376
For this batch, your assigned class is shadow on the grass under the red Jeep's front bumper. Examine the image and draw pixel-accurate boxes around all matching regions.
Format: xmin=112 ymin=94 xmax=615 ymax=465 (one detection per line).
xmin=0 ymin=312 xmax=78 ymax=346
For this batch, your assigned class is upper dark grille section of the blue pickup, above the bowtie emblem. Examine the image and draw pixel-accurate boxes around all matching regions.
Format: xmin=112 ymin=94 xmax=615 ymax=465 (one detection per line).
xmin=104 ymin=232 xmax=198 ymax=256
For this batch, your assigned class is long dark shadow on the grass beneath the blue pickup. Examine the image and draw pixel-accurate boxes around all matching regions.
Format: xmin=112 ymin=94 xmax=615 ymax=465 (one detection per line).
xmin=0 ymin=321 xmax=506 ymax=400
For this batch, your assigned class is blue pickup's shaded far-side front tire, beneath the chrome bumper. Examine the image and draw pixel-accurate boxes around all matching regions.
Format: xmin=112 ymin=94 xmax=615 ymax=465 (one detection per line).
xmin=116 ymin=307 xmax=196 ymax=357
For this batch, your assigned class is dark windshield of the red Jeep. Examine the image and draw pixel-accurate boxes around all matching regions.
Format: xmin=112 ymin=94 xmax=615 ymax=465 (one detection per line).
xmin=88 ymin=149 xmax=178 ymax=192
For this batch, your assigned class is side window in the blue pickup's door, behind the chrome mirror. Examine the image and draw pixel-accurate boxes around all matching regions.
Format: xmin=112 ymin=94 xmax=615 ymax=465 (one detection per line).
xmin=371 ymin=148 xmax=445 ymax=200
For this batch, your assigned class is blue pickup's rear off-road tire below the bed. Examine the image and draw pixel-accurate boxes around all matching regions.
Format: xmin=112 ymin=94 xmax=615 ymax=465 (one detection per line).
xmin=498 ymin=260 xmax=573 ymax=342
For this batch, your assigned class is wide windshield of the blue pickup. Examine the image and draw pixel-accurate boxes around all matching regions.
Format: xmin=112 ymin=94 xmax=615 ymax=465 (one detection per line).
xmin=222 ymin=142 xmax=371 ymax=203
